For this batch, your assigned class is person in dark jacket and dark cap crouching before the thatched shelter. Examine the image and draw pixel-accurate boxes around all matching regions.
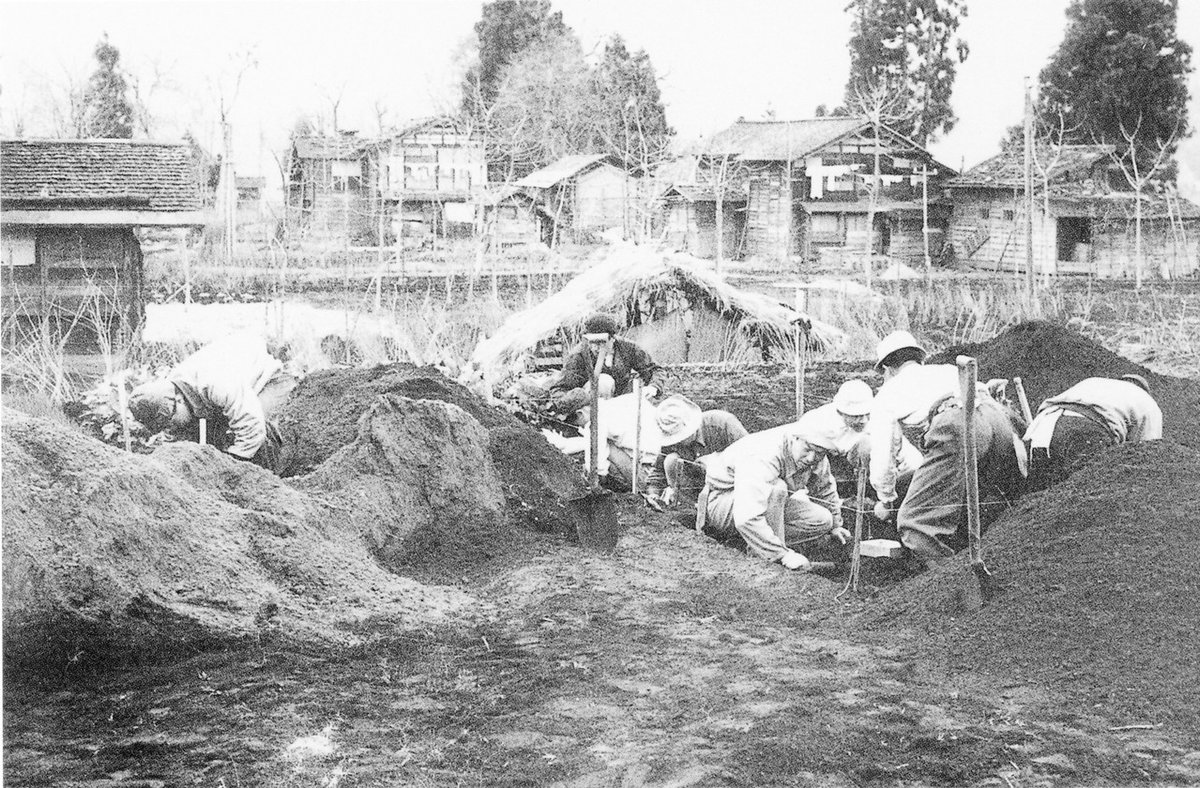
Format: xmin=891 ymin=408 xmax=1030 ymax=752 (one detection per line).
xmin=550 ymin=314 xmax=659 ymax=416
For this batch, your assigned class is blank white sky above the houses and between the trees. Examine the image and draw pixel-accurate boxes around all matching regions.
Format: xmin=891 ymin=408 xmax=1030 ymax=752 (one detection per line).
xmin=0 ymin=0 xmax=1200 ymax=174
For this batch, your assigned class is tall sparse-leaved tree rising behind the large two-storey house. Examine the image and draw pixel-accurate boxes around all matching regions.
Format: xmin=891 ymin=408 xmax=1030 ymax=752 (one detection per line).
xmin=846 ymin=0 xmax=968 ymax=145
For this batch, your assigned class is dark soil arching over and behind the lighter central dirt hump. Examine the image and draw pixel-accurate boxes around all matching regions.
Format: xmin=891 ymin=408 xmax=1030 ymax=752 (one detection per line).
xmin=278 ymin=363 xmax=587 ymax=535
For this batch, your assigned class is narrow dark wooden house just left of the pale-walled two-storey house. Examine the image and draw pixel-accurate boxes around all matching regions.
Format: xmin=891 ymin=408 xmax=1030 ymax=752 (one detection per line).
xmin=287 ymin=132 xmax=369 ymax=246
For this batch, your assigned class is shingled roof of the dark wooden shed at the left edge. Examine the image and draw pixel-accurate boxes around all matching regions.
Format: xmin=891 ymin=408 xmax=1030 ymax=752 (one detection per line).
xmin=0 ymin=139 xmax=200 ymax=211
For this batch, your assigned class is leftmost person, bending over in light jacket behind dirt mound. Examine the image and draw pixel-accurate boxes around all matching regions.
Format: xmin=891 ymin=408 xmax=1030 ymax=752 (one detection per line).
xmin=130 ymin=336 xmax=296 ymax=471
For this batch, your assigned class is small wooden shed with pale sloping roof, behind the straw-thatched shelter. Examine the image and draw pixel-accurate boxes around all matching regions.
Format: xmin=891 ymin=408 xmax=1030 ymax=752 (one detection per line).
xmin=516 ymin=154 xmax=640 ymax=246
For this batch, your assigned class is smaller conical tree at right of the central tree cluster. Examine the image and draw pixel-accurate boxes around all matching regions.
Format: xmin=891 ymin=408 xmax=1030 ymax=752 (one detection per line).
xmin=595 ymin=36 xmax=674 ymax=170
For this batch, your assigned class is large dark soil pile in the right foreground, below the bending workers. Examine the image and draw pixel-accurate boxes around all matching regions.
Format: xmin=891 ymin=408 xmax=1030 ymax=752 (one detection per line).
xmin=872 ymin=441 xmax=1200 ymax=734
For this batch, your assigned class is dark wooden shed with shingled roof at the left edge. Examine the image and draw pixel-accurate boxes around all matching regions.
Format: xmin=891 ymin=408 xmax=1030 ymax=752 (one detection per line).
xmin=0 ymin=139 xmax=204 ymax=345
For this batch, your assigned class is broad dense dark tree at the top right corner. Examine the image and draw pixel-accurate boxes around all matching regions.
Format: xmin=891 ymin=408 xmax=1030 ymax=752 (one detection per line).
xmin=1038 ymin=0 xmax=1192 ymax=173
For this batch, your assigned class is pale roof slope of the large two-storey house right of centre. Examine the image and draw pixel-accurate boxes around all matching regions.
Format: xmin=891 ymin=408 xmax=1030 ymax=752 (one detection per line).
xmin=702 ymin=118 xmax=869 ymax=162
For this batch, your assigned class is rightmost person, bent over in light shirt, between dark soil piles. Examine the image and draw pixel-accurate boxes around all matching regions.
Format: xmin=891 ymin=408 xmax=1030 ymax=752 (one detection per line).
xmin=1025 ymin=374 xmax=1163 ymax=489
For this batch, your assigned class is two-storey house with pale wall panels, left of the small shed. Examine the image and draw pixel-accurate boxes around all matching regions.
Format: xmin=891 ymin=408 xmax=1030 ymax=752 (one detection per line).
xmin=367 ymin=118 xmax=487 ymax=246
